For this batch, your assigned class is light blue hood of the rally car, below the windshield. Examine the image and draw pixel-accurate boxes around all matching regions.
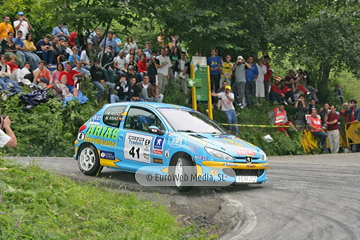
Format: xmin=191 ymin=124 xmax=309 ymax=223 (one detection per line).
xmin=182 ymin=133 xmax=263 ymax=158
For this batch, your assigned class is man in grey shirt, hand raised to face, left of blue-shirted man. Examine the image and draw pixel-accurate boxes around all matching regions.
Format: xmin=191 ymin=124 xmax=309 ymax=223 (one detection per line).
xmin=233 ymin=56 xmax=251 ymax=108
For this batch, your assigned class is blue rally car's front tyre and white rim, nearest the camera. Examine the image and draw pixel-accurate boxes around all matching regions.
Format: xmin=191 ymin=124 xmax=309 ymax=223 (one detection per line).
xmin=171 ymin=155 xmax=194 ymax=192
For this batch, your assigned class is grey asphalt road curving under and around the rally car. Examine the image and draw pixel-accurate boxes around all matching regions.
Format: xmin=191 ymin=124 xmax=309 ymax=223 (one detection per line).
xmin=4 ymin=153 xmax=360 ymax=240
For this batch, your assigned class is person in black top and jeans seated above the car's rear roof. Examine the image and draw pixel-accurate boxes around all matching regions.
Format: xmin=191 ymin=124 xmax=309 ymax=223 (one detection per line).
xmin=90 ymin=60 xmax=115 ymax=99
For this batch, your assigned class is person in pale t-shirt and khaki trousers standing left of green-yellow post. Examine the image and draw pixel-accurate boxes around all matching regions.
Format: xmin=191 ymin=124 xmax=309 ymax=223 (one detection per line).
xmin=156 ymin=48 xmax=171 ymax=94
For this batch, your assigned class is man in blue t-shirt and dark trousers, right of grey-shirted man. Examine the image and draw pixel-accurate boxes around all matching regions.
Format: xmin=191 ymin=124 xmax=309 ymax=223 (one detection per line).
xmin=245 ymin=56 xmax=259 ymax=106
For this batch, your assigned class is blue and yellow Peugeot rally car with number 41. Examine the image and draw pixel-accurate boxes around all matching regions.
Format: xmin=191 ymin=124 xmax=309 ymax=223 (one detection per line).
xmin=74 ymin=102 xmax=269 ymax=191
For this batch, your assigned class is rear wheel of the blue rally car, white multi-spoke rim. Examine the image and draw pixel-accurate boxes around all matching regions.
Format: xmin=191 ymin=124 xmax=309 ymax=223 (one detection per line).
xmin=78 ymin=143 xmax=103 ymax=176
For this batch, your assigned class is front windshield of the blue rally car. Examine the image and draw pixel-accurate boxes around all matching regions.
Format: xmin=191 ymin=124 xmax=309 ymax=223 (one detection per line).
xmin=158 ymin=108 xmax=226 ymax=134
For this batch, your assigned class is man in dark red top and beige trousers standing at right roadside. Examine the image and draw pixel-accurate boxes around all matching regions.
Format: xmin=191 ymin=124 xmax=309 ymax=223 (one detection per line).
xmin=325 ymin=105 xmax=340 ymax=153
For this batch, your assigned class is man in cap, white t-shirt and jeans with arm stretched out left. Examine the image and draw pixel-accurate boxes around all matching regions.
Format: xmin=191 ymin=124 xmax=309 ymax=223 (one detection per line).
xmin=211 ymin=86 xmax=239 ymax=134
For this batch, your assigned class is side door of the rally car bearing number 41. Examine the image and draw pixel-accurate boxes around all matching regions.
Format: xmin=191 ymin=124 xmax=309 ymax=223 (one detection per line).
xmin=123 ymin=106 xmax=166 ymax=171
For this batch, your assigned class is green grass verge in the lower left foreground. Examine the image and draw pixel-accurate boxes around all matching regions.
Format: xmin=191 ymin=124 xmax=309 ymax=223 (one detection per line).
xmin=0 ymin=159 xmax=205 ymax=240
